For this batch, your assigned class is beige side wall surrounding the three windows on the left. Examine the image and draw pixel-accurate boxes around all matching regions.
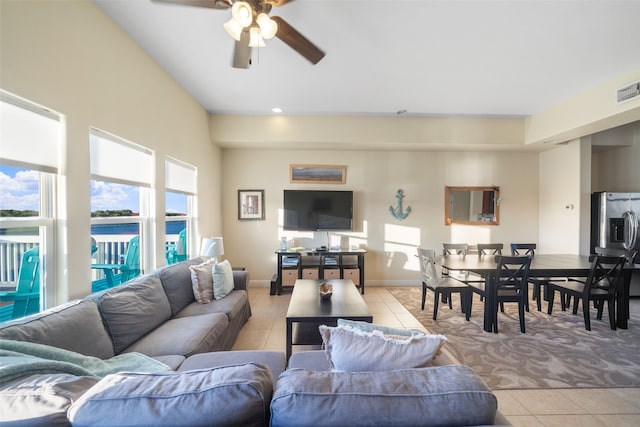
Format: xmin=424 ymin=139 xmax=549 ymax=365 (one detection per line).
xmin=0 ymin=0 xmax=222 ymax=304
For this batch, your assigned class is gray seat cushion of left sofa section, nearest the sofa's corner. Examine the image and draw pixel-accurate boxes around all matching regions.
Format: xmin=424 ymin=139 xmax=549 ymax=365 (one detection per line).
xmin=125 ymin=313 xmax=229 ymax=357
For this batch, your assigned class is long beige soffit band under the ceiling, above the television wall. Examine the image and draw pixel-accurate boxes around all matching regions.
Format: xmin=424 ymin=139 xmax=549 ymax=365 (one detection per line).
xmin=211 ymin=115 xmax=524 ymax=151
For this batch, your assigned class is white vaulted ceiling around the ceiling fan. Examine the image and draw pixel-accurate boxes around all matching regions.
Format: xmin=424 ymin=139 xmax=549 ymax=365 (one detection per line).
xmin=95 ymin=0 xmax=640 ymax=117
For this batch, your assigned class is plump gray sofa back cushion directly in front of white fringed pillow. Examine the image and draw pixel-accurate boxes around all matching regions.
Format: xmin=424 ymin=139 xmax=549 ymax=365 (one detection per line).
xmin=271 ymin=365 xmax=498 ymax=427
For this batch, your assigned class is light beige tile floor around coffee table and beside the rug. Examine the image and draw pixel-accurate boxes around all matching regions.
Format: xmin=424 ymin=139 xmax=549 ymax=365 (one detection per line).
xmin=233 ymin=287 xmax=640 ymax=427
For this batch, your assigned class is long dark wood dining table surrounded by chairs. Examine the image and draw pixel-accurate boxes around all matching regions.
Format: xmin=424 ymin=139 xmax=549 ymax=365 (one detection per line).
xmin=440 ymin=254 xmax=639 ymax=332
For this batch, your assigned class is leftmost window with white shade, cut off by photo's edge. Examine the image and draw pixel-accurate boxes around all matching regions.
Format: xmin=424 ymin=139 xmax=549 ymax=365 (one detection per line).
xmin=0 ymin=91 xmax=61 ymax=321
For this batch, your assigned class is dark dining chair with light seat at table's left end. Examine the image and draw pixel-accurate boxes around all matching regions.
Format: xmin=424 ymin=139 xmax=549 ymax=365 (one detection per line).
xmin=418 ymin=248 xmax=470 ymax=320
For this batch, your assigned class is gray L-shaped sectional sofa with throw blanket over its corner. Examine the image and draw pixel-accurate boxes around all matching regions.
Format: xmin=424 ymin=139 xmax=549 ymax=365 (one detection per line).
xmin=0 ymin=259 xmax=506 ymax=426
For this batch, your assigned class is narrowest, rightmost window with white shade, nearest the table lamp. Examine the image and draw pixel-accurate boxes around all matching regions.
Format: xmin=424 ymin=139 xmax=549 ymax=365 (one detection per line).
xmin=165 ymin=157 xmax=196 ymax=264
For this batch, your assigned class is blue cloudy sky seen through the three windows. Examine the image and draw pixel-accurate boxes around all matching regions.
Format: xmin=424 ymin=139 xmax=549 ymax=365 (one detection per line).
xmin=0 ymin=166 xmax=186 ymax=212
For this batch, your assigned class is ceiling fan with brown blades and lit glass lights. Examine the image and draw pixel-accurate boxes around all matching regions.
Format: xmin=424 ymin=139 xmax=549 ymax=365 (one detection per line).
xmin=151 ymin=0 xmax=325 ymax=68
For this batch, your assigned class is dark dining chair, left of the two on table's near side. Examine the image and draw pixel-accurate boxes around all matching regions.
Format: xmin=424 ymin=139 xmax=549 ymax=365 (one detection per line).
xmin=467 ymin=255 xmax=531 ymax=334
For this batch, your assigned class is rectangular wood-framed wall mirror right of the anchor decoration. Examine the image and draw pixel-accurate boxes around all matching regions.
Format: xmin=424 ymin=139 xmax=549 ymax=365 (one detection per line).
xmin=444 ymin=187 xmax=500 ymax=225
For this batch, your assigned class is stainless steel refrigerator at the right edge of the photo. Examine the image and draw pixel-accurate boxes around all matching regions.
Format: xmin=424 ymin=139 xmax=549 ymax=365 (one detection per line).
xmin=591 ymin=191 xmax=640 ymax=296
